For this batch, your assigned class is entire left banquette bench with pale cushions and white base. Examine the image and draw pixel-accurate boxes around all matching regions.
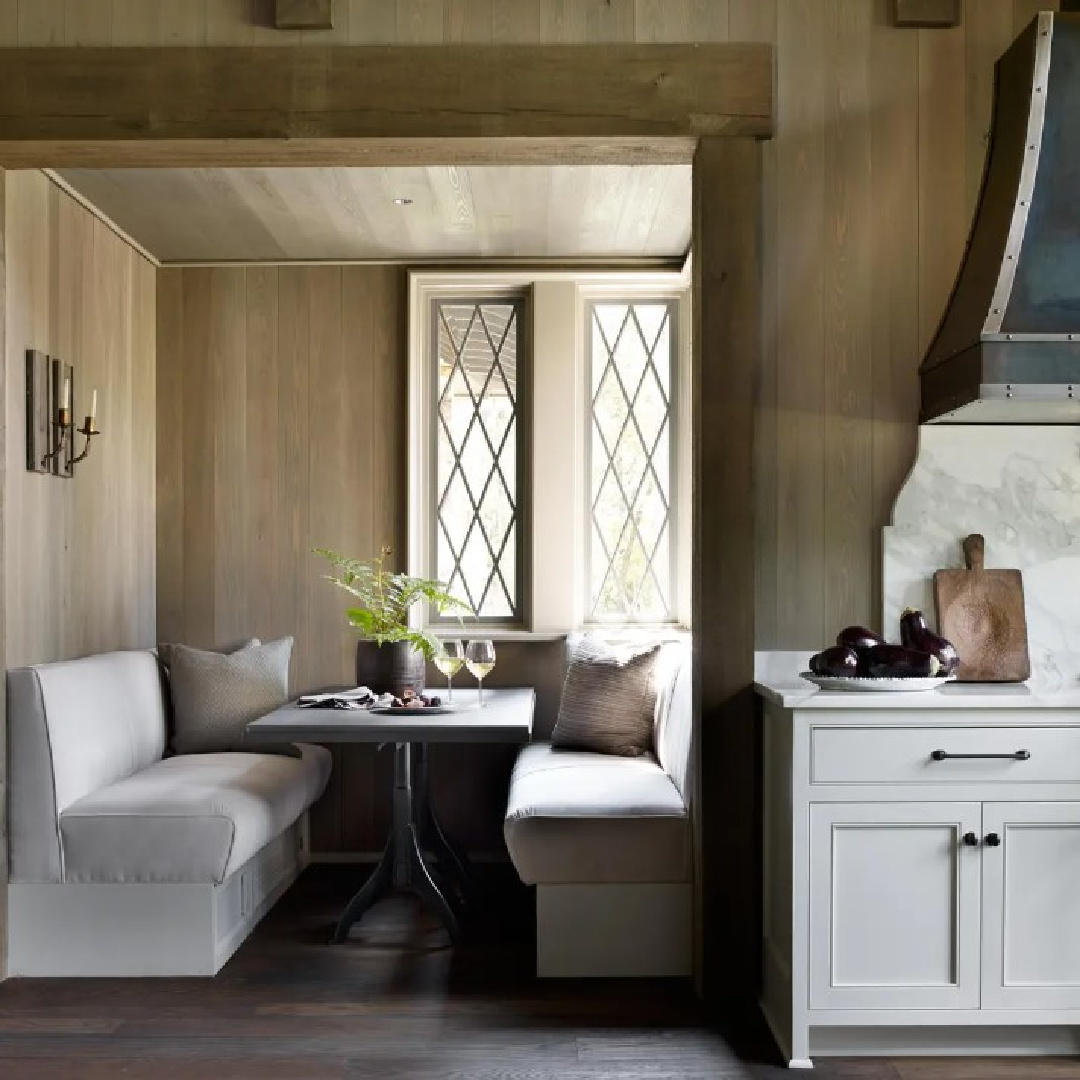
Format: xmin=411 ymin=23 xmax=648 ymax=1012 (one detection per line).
xmin=8 ymin=651 xmax=330 ymax=975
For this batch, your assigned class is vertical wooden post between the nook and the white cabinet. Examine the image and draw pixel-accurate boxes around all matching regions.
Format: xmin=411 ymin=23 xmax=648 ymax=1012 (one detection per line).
xmin=691 ymin=136 xmax=761 ymax=1005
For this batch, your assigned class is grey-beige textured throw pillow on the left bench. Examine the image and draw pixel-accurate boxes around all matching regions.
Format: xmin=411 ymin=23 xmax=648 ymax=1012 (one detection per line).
xmin=168 ymin=637 xmax=293 ymax=754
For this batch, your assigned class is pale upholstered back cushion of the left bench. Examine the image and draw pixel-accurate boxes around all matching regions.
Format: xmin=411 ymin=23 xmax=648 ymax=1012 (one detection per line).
xmin=8 ymin=651 xmax=165 ymax=881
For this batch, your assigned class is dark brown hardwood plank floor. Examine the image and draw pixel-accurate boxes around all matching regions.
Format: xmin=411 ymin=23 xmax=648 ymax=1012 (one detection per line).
xmin=0 ymin=866 xmax=1080 ymax=1080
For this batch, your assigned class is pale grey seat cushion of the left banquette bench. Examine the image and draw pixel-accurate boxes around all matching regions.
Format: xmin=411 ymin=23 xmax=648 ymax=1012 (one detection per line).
xmin=60 ymin=745 xmax=330 ymax=883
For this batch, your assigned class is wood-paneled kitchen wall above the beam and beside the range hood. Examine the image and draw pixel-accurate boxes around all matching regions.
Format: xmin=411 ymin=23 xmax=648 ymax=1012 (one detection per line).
xmin=0 ymin=0 xmax=1057 ymax=648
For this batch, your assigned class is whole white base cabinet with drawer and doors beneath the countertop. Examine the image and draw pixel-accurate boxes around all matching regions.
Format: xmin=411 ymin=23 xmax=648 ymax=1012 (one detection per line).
xmin=759 ymin=686 xmax=1080 ymax=1067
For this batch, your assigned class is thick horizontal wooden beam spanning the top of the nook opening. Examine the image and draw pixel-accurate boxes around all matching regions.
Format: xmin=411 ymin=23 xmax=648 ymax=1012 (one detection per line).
xmin=0 ymin=44 xmax=773 ymax=168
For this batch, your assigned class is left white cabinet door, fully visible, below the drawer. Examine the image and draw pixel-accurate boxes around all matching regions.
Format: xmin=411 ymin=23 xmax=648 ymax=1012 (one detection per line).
xmin=810 ymin=802 xmax=981 ymax=1009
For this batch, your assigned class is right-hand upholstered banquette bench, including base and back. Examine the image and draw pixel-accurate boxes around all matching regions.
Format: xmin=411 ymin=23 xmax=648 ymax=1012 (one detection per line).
xmin=503 ymin=638 xmax=693 ymax=977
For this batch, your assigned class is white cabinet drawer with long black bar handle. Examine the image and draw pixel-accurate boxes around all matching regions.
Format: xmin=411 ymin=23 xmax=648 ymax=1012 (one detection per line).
xmin=810 ymin=725 xmax=1080 ymax=784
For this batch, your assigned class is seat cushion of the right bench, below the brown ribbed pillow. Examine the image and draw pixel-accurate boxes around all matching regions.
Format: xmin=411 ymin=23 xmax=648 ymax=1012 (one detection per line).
xmin=503 ymin=743 xmax=690 ymax=885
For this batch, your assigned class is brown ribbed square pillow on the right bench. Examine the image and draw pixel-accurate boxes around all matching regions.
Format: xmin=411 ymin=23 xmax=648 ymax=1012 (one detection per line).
xmin=551 ymin=635 xmax=660 ymax=757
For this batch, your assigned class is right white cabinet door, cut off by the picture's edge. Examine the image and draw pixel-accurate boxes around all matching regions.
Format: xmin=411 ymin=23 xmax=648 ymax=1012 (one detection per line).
xmin=983 ymin=802 xmax=1080 ymax=1009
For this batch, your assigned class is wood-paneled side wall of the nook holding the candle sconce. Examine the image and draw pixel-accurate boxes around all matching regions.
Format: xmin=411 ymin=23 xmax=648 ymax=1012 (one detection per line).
xmin=0 ymin=172 xmax=156 ymax=974
